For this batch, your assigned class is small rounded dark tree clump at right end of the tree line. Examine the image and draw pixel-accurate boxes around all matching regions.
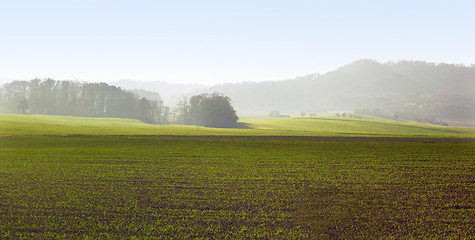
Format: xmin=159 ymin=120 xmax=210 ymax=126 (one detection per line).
xmin=175 ymin=93 xmax=238 ymax=128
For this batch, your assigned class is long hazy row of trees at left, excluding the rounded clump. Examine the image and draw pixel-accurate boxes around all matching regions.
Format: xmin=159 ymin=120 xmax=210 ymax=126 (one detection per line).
xmin=0 ymin=79 xmax=168 ymax=123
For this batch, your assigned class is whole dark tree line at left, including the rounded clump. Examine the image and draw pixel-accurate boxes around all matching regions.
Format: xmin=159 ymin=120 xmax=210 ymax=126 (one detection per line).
xmin=0 ymin=79 xmax=238 ymax=127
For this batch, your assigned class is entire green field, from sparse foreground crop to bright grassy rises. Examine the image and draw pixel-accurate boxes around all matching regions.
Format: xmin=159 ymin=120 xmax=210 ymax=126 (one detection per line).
xmin=0 ymin=115 xmax=475 ymax=239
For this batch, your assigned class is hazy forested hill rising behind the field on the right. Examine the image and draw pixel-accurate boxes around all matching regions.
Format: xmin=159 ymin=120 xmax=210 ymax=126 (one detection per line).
xmin=194 ymin=60 xmax=475 ymax=121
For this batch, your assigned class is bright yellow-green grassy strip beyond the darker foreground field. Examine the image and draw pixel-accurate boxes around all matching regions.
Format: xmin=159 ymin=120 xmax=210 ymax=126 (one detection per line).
xmin=0 ymin=114 xmax=475 ymax=138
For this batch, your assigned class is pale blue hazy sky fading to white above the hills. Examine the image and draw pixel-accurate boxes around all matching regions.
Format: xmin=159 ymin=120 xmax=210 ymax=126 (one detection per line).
xmin=0 ymin=0 xmax=475 ymax=84
